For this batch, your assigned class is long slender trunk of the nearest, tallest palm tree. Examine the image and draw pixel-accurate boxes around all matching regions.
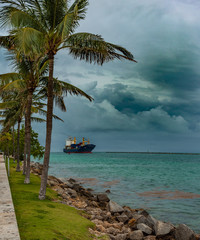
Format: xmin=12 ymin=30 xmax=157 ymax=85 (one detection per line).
xmin=39 ymin=53 xmax=54 ymax=200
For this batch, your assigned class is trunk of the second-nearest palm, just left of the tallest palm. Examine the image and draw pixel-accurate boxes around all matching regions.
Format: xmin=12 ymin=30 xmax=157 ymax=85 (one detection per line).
xmin=24 ymin=90 xmax=33 ymax=184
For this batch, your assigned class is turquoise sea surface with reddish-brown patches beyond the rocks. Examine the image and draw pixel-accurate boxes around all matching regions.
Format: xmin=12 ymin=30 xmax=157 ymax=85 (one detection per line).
xmin=45 ymin=152 xmax=200 ymax=233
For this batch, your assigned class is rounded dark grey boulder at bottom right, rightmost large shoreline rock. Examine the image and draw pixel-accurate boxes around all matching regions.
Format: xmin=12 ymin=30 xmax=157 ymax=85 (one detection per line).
xmin=175 ymin=224 xmax=196 ymax=240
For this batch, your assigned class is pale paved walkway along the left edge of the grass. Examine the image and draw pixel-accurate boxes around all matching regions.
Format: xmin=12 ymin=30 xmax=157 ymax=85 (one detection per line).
xmin=0 ymin=155 xmax=20 ymax=240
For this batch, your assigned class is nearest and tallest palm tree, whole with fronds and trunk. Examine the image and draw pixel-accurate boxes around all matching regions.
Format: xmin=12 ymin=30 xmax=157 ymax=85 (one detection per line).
xmin=0 ymin=0 xmax=135 ymax=199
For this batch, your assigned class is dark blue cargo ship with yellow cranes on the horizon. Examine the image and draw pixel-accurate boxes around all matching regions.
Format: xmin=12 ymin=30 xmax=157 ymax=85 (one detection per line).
xmin=63 ymin=137 xmax=96 ymax=154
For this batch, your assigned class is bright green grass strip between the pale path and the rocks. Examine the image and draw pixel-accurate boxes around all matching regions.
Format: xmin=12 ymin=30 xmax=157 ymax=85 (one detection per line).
xmin=9 ymin=161 xmax=94 ymax=240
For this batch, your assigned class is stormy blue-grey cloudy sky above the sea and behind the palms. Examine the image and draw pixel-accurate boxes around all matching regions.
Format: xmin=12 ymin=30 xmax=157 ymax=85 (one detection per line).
xmin=0 ymin=0 xmax=200 ymax=152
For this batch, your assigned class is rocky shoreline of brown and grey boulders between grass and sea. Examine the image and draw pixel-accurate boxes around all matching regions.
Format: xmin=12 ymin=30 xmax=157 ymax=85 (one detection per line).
xmin=31 ymin=162 xmax=200 ymax=240
